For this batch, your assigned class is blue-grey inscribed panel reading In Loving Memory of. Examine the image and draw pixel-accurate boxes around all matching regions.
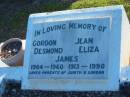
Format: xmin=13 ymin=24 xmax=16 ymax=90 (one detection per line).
xmin=28 ymin=17 xmax=111 ymax=79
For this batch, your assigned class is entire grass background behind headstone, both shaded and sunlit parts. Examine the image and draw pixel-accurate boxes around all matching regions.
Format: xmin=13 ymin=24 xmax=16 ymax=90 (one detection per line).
xmin=0 ymin=0 xmax=130 ymax=42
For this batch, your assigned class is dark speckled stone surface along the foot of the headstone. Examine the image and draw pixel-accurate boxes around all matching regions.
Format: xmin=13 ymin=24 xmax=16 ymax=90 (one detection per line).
xmin=2 ymin=82 xmax=130 ymax=97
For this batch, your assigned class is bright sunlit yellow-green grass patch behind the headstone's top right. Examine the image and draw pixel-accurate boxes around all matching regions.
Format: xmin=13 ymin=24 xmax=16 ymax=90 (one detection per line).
xmin=70 ymin=0 xmax=130 ymax=19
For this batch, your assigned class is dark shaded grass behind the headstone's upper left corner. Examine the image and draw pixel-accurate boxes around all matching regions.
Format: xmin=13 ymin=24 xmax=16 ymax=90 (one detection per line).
xmin=0 ymin=0 xmax=72 ymax=42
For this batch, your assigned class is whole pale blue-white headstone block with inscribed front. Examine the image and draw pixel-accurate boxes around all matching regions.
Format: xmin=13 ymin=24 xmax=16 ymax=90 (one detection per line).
xmin=22 ymin=6 xmax=129 ymax=91
